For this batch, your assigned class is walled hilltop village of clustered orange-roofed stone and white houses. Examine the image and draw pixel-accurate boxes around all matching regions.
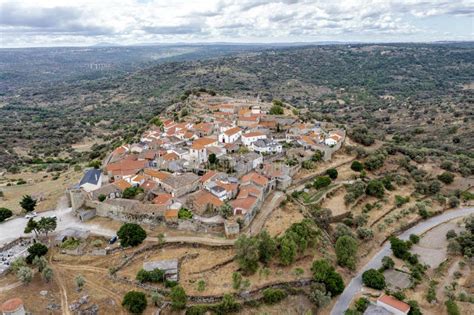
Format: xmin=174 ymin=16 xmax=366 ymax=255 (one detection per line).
xmin=69 ymin=94 xmax=345 ymax=238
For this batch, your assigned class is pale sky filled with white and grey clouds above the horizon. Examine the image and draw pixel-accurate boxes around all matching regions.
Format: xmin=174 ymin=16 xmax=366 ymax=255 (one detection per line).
xmin=0 ymin=0 xmax=474 ymax=48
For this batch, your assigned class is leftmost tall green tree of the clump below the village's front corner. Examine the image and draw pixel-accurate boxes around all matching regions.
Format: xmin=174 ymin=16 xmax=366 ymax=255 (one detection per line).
xmin=235 ymin=234 xmax=259 ymax=274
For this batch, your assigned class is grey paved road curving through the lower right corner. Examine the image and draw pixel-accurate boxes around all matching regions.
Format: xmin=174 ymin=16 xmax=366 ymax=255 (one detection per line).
xmin=331 ymin=208 xmax=474 ymax=315
